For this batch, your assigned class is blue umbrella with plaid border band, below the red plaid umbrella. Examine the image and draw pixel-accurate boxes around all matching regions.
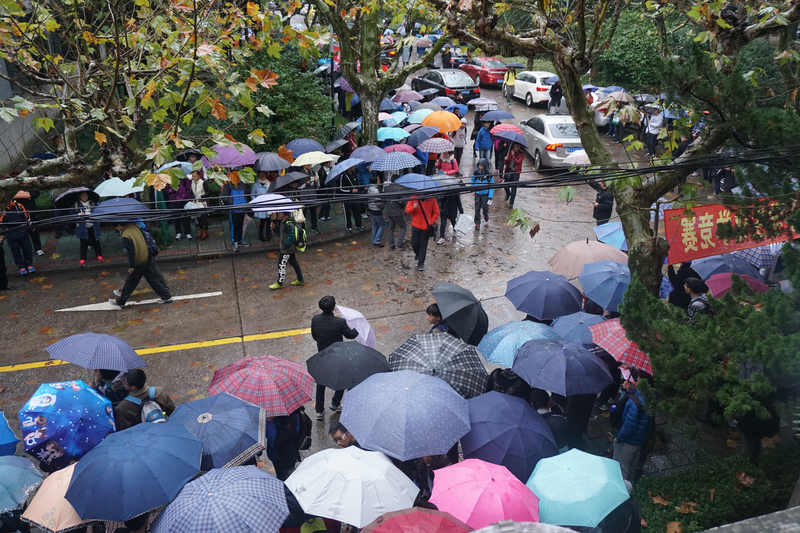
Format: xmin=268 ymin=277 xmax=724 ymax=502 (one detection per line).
xmin=167 ymin=392 xmax=267 ymax=472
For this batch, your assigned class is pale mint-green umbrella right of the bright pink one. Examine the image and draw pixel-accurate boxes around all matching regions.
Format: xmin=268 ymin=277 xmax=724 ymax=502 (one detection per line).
xmin=527 ymin=449 xmax=628 ymax=527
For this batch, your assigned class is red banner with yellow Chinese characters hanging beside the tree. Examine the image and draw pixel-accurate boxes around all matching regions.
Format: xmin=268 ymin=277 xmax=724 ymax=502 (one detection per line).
xmin=664 ymin=204 xmax=788 ymax=265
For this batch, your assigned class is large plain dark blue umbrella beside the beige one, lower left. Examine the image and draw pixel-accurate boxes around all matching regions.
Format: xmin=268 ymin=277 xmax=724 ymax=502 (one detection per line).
xmin=66 ymin=424 xmax=203 ymax=522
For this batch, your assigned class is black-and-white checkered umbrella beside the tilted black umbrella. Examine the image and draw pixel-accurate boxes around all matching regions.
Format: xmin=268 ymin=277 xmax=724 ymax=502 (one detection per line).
xmin=389 ymin=333 xmax=488 ymax=399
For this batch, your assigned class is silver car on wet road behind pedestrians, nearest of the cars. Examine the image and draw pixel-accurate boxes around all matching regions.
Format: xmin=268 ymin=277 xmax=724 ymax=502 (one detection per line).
xmin=519 ymin=115 xmax=583 ymax=170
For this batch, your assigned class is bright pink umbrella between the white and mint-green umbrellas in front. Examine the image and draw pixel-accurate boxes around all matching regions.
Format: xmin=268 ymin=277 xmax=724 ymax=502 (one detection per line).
xmin=430 ymin=459 xmax=539 ymax=529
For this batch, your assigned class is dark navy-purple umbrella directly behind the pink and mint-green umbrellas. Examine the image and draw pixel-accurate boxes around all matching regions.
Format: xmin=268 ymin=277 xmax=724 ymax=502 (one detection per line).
xmin=461 ymin=391 xmax=558 ymax=482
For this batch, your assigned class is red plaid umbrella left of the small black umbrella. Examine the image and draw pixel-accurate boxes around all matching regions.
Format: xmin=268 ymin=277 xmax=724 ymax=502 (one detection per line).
xmin=208 ymin=355 xmax=314 ymax=416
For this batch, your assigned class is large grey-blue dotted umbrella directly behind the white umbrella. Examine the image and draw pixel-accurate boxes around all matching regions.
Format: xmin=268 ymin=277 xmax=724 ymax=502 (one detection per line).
xmin=341 ymin=368 xmax=469 ymax=461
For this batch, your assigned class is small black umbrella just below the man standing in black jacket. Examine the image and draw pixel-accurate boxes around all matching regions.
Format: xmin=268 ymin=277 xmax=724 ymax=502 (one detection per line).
xmin=306 ymin=342 xmax=391 ymax=390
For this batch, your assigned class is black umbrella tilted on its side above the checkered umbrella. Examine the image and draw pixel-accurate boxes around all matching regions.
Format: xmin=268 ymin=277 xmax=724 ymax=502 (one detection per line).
xmin=433 ymin=281 xmax=489 ymax=346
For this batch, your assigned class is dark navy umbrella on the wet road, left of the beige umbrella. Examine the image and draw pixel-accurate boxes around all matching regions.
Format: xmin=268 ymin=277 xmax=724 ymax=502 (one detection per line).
xmin=506 ymin=270 xmax=583 ymax=320
